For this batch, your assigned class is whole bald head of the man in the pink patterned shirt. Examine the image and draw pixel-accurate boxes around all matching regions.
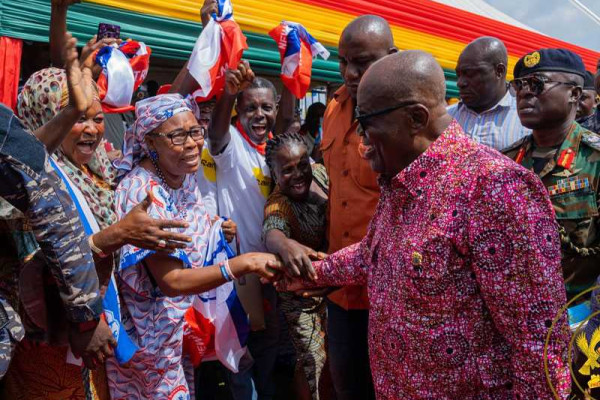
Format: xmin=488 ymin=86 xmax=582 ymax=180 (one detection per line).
xmin=357 ymin=50 xmax=452 ymax=177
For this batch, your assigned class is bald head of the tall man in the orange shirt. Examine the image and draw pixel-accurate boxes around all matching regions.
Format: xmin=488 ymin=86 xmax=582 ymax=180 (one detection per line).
xmin=338 ymin=15 xmax=397 ymax=101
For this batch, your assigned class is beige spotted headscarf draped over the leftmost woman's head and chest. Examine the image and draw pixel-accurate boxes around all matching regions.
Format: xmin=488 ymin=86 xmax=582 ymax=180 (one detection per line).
xmin=17 ymin=68 xmax=117 ymax=229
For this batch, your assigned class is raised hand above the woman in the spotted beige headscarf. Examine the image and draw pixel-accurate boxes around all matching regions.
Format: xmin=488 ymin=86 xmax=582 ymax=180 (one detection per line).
xmin=63 ymin=33 xmax=94 ymax=113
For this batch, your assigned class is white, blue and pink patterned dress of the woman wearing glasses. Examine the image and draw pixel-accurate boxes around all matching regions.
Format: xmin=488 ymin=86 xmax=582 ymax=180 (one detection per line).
xmin=106 ymin=166 xmax=210 ymax=400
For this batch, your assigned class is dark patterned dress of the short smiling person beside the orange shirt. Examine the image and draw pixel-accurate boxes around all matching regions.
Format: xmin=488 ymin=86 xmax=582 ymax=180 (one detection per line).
xmin=263 ymin=164 xmax=329 ymax=400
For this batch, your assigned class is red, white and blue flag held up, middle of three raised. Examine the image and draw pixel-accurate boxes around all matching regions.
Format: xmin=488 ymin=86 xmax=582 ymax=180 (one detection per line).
xmin=188 ymin=0 xmax=248 ymax=102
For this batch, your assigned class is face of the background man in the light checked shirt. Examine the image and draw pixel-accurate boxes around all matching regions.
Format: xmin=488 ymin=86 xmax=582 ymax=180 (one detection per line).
xmin=456 ymin=52 xmax=504 ymax=112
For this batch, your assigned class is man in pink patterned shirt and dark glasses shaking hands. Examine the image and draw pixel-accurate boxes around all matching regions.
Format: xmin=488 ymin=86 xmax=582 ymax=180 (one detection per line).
xmin=281 ymin=51 xmax=570 ymax=400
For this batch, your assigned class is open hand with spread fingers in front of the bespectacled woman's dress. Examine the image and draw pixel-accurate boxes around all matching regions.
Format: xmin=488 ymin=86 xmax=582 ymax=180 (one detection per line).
xmin=118 ymin=192 xmax=192 ymax=253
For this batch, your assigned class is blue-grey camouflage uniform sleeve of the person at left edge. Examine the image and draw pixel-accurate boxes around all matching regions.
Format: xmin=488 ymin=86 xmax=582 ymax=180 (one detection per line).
xmin=0 ymin=105 xmax=102 ymax=371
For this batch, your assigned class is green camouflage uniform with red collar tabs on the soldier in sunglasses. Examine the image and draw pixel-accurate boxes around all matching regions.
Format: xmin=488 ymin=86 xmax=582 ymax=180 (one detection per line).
xmin=503 ymin=123 xmax=600 ymax=298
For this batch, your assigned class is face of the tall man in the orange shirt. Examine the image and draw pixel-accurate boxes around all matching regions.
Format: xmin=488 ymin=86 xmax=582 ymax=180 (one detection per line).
xmin=339 ymin=32 xmax=392 ymax=100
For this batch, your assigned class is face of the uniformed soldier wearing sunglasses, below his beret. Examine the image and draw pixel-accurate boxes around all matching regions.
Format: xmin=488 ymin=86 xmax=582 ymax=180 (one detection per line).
xmin=517 ymin=72 xmax=581 ymax=129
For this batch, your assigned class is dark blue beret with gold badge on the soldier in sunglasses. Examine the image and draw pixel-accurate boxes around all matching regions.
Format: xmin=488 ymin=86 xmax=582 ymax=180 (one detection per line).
xmin=513 ymin=49 xmax=585 ymax=78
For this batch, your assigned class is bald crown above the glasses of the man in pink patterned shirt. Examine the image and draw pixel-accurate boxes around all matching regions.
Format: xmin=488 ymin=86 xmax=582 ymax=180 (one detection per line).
xmin=358 ymin=50 xmax=446 ymax=112
